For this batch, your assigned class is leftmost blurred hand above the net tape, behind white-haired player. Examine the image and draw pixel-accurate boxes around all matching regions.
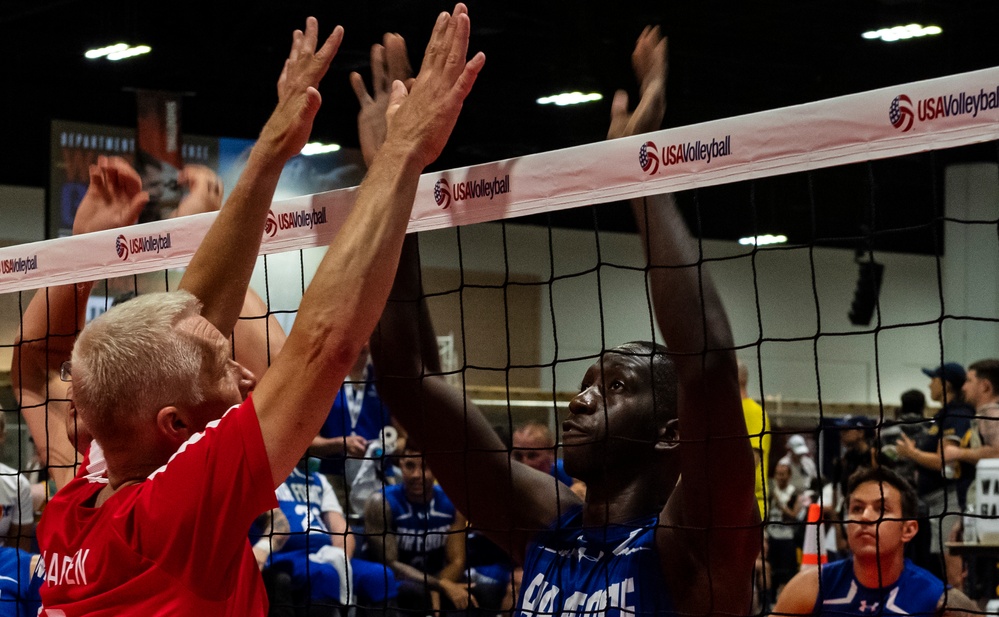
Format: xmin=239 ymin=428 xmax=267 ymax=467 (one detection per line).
xmin=73 ymin=156 xmax=149 ymax=235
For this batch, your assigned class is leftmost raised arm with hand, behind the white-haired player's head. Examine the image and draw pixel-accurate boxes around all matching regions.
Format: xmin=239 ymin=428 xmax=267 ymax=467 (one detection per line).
xmin=10 ymin=156 xmax=149 ymax=488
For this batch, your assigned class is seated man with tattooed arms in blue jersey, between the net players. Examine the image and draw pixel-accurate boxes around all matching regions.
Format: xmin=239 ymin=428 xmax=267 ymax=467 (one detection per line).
xmin=364 ymin=448 xmax=478 ymax=615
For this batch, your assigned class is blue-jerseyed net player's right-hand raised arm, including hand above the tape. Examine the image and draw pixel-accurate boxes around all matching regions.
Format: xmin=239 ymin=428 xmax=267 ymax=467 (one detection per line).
xmin=609 ymin=28 xmax=760 ymax=612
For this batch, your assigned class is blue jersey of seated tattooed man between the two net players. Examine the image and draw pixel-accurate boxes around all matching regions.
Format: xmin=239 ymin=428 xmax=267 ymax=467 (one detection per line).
xmin=385 ymin=484 xmax=455 ymax=574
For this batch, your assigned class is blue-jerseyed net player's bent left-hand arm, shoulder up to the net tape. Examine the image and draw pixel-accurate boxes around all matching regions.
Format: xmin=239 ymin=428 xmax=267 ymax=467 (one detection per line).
xmin=371 ymin=235 xmax=580 ymax=561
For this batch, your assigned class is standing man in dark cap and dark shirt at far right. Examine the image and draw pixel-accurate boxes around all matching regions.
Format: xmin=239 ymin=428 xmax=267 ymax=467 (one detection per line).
xmin=896 ymin=362 xmax=975 ymax=586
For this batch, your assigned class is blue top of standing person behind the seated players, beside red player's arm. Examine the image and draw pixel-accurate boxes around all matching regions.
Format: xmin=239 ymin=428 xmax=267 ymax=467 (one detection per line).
xmin=319 ymin=364 xmax=392 ymax=475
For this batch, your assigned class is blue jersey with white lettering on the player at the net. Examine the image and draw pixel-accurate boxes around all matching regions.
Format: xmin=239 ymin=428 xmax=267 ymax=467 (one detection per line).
xmin=516 ymin=506 xmax=674 ymax=617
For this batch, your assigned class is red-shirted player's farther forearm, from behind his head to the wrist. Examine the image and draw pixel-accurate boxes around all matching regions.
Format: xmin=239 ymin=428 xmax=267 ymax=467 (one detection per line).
xmin=180 ymin=145 xmax=287 ymax=336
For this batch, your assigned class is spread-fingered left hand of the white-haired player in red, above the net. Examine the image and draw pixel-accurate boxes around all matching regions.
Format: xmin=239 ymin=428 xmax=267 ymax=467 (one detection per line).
xmin=260 ymin=17 xmax=343 ymax=159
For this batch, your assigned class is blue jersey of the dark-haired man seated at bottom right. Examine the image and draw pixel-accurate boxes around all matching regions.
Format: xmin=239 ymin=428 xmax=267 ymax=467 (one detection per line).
xmin=815 ymin=559 xmax=944 ymax=617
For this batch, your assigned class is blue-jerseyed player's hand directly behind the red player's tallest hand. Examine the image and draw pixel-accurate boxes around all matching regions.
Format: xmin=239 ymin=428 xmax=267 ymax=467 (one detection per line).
xmin=350 ymin=33 xmax=413 ymax=166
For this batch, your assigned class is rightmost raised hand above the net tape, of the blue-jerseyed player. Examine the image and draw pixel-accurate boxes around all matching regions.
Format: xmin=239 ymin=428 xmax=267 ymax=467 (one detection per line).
xmin=607 ymin=26 xmax=669 ymax=139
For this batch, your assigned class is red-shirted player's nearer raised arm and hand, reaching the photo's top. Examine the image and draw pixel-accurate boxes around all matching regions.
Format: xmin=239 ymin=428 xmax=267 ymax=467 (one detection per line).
xmin=254 ymin=4 xmax=485 ymax=486
